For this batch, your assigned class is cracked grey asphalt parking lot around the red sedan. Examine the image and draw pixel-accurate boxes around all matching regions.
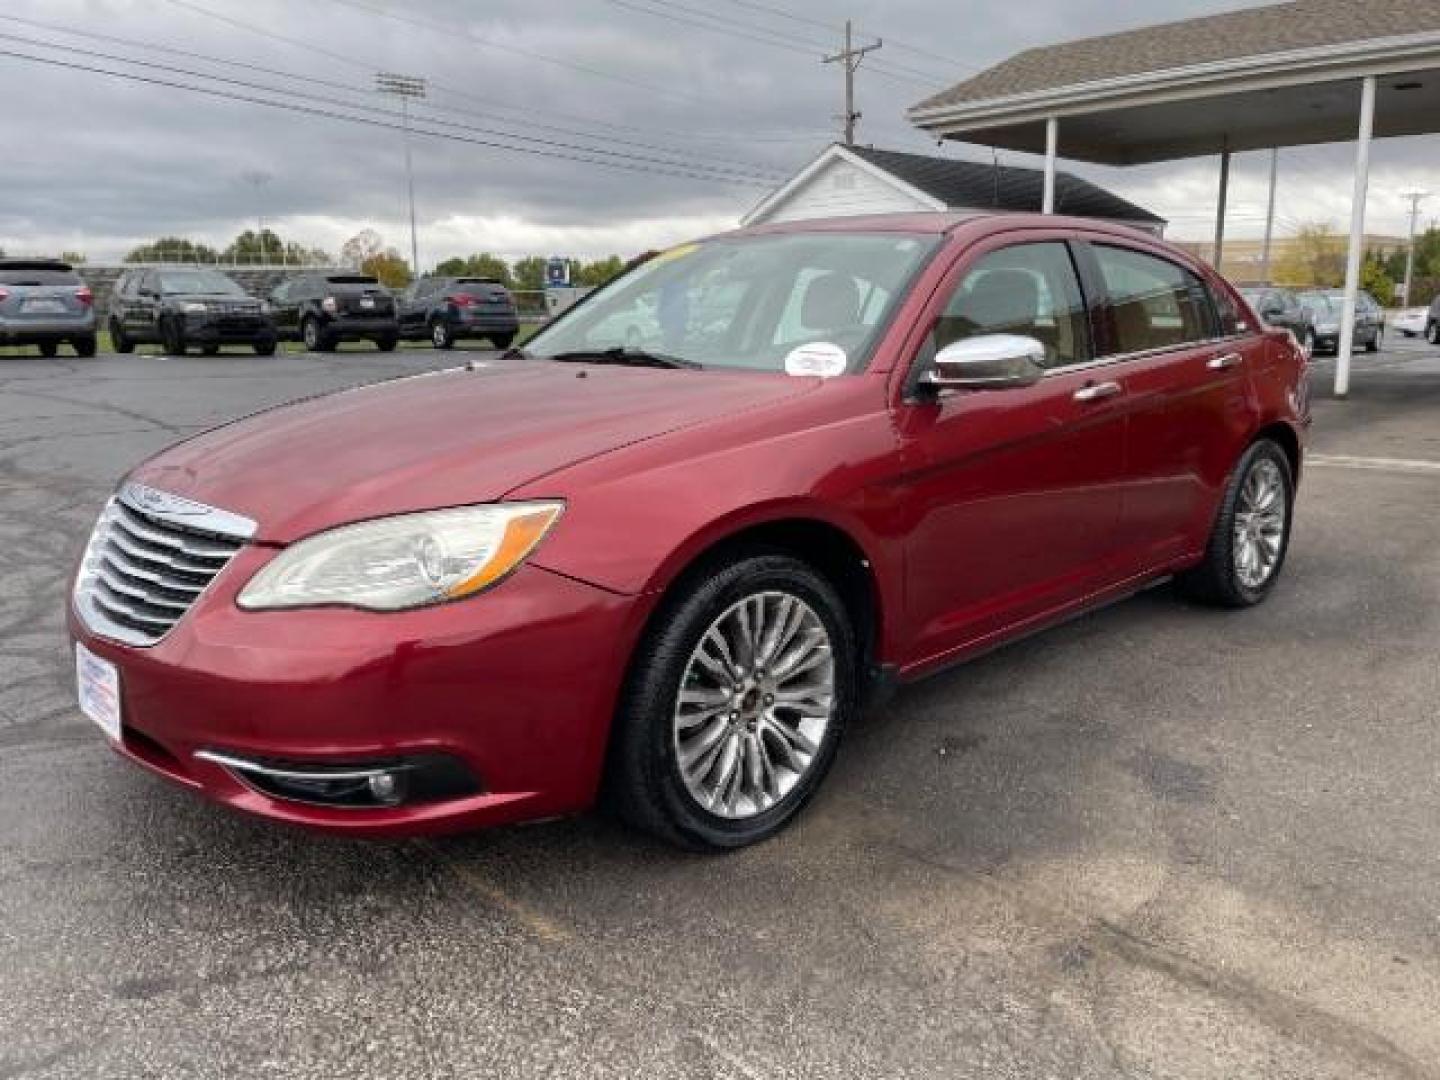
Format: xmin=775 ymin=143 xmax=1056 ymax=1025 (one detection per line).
xmin=8 ymin=344 xmax=1440 ymax=1080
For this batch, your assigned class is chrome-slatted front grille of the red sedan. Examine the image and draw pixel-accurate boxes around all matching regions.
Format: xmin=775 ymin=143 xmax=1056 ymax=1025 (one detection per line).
xmin=75 ymin=484 xmax=255 ymax=645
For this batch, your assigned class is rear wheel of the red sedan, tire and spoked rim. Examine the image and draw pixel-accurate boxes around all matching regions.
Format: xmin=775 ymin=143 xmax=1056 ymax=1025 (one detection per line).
xmin=1176 ymin=439 xmax=1295 ymax=608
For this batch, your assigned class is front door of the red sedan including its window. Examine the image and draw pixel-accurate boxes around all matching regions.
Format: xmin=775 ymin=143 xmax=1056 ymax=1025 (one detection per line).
xmin=897 ymin=238 xmax=1125 ymax=665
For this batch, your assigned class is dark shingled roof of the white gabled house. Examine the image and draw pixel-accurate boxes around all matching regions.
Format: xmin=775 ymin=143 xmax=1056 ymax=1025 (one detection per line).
xmin=840 ymin=147 xmax=1165 ymax=225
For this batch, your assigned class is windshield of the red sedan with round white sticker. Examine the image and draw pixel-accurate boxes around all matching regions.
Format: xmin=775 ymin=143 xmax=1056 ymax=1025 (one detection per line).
xmin=526 ymin=233 xmax=940 ymax=374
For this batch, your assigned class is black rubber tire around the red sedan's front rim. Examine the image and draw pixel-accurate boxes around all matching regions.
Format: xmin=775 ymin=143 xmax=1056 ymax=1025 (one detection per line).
xmin=605 ymin=552 xmax=860 ymax=851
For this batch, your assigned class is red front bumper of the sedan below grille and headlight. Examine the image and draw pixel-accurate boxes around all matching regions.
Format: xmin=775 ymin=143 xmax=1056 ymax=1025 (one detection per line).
xmin=69 ymin=547 xmax=639 ymax=837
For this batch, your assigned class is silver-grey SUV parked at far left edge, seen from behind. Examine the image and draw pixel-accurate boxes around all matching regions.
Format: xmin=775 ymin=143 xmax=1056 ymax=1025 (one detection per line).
xmin=0 ymin=259 xmax=95 ymax=356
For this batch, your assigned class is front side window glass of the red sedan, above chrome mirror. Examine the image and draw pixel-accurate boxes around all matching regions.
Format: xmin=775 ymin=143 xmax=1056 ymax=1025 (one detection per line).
xmin=924 ymin=242 xmax=1090 ymax=367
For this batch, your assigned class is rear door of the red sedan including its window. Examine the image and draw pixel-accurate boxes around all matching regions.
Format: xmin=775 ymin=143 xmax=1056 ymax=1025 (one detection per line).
xmin=1081 ymin=239 xmax=1264 ymax=573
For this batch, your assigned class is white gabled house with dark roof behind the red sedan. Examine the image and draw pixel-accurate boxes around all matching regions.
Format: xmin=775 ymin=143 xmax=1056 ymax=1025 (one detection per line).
xmin=740 ymin=143 xmax=1165 ymax=236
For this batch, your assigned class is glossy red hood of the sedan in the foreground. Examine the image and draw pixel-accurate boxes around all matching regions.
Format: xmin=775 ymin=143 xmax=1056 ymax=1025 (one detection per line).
xmin=131 ymin=360 xmax=821 ymax=543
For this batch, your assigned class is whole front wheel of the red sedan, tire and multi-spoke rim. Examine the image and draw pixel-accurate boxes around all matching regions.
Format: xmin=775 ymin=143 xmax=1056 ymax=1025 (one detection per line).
xmin=606 ymin=554 xmax=857 ymax=848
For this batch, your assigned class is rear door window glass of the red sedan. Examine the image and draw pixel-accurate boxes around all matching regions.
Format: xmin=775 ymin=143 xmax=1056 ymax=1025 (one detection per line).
xmin=1093 ymin=245 xmax=1211 ymax=353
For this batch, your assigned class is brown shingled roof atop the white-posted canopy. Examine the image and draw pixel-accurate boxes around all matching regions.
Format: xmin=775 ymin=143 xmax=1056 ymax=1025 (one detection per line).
xmin=912 ymin=0 xmax=1440 ymax=114
